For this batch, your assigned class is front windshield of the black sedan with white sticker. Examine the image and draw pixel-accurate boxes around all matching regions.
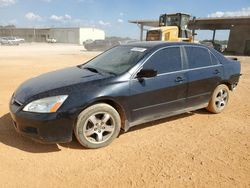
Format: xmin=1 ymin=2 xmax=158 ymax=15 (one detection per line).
xmin=80 ymin=46 xmax=147 ymax=75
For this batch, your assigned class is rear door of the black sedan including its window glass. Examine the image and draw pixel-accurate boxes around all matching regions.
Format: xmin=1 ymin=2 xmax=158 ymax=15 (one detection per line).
xmin=184 ymin=46 xmax=223 ymax=108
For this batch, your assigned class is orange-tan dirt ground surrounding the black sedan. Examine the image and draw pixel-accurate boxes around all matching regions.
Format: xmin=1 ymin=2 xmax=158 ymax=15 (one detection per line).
xmin=0 ymin=44 xmax=250 ymax=188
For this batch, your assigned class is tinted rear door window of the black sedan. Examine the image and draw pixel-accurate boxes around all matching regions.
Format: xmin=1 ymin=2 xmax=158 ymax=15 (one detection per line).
xmin=185 ymin=46 xmax=212 ymax=69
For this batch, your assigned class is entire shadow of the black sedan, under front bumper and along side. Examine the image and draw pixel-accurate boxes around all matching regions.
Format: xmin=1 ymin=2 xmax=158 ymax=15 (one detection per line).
xmin=0 ymin=110 xmax=206 ymax=153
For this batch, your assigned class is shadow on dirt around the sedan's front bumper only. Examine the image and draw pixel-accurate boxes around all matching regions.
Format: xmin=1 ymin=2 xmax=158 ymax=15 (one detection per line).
xmin=0 ymin=113 xmax=84 ymax=153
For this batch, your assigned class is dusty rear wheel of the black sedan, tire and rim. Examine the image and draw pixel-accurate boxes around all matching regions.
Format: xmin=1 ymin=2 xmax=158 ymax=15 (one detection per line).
xmin=206 ymin=84 xmax=229 ymax=114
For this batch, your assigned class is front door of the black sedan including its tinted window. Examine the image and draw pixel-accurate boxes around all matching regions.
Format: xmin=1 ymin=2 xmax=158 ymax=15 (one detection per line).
xmin=129 ymin=47 xmax=187 ymax=125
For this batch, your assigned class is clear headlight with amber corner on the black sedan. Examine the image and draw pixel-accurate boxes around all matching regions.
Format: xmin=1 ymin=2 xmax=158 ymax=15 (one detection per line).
xmin=23 ymin=95 xmax=68 ymax=113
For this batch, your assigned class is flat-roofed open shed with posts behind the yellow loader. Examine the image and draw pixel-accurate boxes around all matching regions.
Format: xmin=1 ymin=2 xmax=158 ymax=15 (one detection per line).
xmin=129 ymin=17 xmax=250 ymax=55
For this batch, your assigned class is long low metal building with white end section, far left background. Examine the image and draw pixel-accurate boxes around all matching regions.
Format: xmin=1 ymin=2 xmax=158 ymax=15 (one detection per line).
xmin=0 ymin=27 xmax=105 ymax=44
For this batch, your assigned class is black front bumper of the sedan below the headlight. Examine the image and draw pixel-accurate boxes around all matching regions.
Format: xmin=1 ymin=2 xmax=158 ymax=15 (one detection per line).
xmin=9 ymin=97 xmax=74 ymax=143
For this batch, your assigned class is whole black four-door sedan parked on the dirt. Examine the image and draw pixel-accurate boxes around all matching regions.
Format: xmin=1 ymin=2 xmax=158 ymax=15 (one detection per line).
xmin=10 ymin=42 xmax=241 ymax=148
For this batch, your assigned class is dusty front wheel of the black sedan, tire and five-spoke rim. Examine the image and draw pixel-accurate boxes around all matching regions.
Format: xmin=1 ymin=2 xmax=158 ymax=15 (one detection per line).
xmin=74 ymin=103 xmax=121 ymax=149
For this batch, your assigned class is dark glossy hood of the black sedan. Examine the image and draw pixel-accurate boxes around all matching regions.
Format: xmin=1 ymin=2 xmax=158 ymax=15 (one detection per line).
xmin=15 ymin=67 xmax=110 ymax=103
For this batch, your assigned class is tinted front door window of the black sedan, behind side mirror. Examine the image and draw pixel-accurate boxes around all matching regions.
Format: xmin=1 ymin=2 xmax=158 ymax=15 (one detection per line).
xmin=143 ymin=47 xmax=182 ymax=74
